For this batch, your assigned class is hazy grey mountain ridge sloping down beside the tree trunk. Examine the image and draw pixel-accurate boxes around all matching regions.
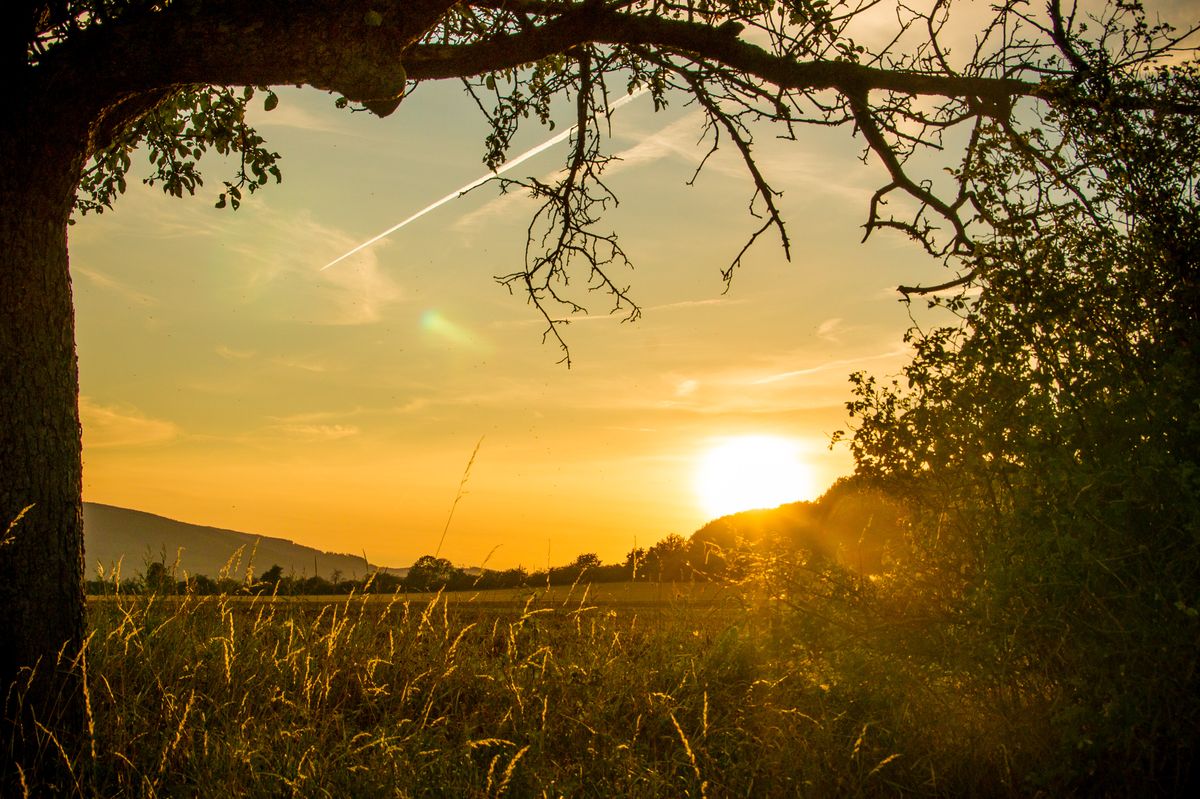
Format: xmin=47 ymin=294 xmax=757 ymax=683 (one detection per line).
xmin=83 ymin=503 xmax=373 ymax=579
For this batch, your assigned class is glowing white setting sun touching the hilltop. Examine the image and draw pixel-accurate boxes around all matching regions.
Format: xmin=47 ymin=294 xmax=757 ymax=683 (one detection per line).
xmin=696 ymin=435 xmax=814 ymax=518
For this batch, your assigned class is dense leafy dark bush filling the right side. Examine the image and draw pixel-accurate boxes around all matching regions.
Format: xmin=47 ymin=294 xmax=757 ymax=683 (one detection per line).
xmin=850 ymin=52 xmax=1200 ymax=795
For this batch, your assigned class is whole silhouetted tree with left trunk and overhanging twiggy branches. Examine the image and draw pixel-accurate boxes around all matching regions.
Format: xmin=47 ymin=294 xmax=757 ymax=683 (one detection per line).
xmin=0 ymin=0 xmax=1195 ymax=779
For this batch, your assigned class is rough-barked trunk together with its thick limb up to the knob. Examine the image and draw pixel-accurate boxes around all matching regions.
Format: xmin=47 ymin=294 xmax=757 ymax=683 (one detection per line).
xmin=0 ymin=0 xmax=451 ymax=782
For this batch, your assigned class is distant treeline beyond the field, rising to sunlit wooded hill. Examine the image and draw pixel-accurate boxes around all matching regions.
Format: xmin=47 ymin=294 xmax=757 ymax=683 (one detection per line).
xmin=86 ymin=481 xmax=900 ymax=596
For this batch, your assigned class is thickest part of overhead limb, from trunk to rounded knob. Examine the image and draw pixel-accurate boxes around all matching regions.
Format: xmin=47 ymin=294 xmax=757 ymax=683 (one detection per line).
xmin=37 ymin=0 xmax=454 ymax=148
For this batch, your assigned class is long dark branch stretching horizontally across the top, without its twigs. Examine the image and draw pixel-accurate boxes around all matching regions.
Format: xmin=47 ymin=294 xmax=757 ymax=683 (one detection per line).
xmin=31 ymin=0 xmax=1196 ymax=166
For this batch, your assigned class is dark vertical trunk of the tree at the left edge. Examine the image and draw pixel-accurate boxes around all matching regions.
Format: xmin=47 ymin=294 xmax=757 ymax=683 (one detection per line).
xmin=0 ymin=121 xmax=86 ymax=795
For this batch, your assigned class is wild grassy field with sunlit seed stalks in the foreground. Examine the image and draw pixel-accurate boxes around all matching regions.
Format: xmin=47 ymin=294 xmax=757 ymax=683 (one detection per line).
xmin=9 ymin=584 xmax=1046 ymax=797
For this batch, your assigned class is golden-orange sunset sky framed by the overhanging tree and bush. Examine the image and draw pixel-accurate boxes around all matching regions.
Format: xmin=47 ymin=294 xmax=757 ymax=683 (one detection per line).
xmin=70 ymin=66 xmax=942 ymax=571
